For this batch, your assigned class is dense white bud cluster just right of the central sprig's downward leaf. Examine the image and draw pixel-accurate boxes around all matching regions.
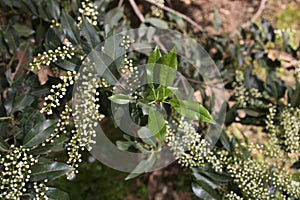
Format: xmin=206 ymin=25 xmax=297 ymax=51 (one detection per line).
xmin=165 ymin=118 xmax=226 ymax=172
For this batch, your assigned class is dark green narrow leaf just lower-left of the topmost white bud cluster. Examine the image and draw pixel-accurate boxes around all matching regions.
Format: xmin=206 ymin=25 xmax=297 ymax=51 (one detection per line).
xmin=60 ymin=11 xmax=81 ymax=45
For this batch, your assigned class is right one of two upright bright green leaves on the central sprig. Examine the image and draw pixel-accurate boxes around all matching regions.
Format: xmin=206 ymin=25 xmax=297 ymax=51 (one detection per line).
xmin=159 ymin=48 xmax=178 ymax=87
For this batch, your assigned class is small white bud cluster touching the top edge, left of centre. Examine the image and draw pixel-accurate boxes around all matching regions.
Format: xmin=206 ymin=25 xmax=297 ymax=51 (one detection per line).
xmin=78 ymin=0 xmax=99 ymax=26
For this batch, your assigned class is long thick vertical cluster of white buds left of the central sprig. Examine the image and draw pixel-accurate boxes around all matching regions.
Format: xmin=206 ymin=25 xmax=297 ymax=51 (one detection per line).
xmin=73 ymin=58 xmax=105 ymax=151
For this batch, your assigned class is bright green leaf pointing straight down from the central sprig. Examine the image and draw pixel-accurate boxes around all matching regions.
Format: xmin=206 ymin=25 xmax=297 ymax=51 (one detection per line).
xmin=148 ymin=109 xmax=166 ymax=141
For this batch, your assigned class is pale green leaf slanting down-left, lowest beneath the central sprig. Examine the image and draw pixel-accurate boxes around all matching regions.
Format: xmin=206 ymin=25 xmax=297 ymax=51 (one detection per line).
xmin=125 ymin=153 xmax=156 ymax=180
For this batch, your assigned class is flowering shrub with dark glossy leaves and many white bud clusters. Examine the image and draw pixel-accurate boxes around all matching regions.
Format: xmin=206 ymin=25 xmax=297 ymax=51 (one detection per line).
xmin=0 ymin=0 xmax=300 ymax=199
